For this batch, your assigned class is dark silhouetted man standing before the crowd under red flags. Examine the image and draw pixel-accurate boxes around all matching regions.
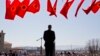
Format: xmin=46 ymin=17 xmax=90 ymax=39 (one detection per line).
xmin=43 ymin=25 xmax=55 ymax=56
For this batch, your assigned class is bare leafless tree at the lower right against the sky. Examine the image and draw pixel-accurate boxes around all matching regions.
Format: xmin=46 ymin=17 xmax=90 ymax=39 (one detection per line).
xmin=87 ymin=39 xmax=100 ymax=56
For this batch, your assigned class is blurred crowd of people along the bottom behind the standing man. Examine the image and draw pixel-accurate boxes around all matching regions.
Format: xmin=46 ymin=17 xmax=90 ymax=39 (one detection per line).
xmin=0 ymin=50 xmax=99 ymax=56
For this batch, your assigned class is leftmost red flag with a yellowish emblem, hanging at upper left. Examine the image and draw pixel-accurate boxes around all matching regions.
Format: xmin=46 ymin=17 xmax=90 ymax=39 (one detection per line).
xmin=5 ymin=0 xmax=20 ymax=20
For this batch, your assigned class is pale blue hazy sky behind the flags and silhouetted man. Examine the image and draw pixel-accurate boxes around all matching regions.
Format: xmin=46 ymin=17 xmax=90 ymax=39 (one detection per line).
xmin=0 ymin=0 xmax=100 ymax=47
